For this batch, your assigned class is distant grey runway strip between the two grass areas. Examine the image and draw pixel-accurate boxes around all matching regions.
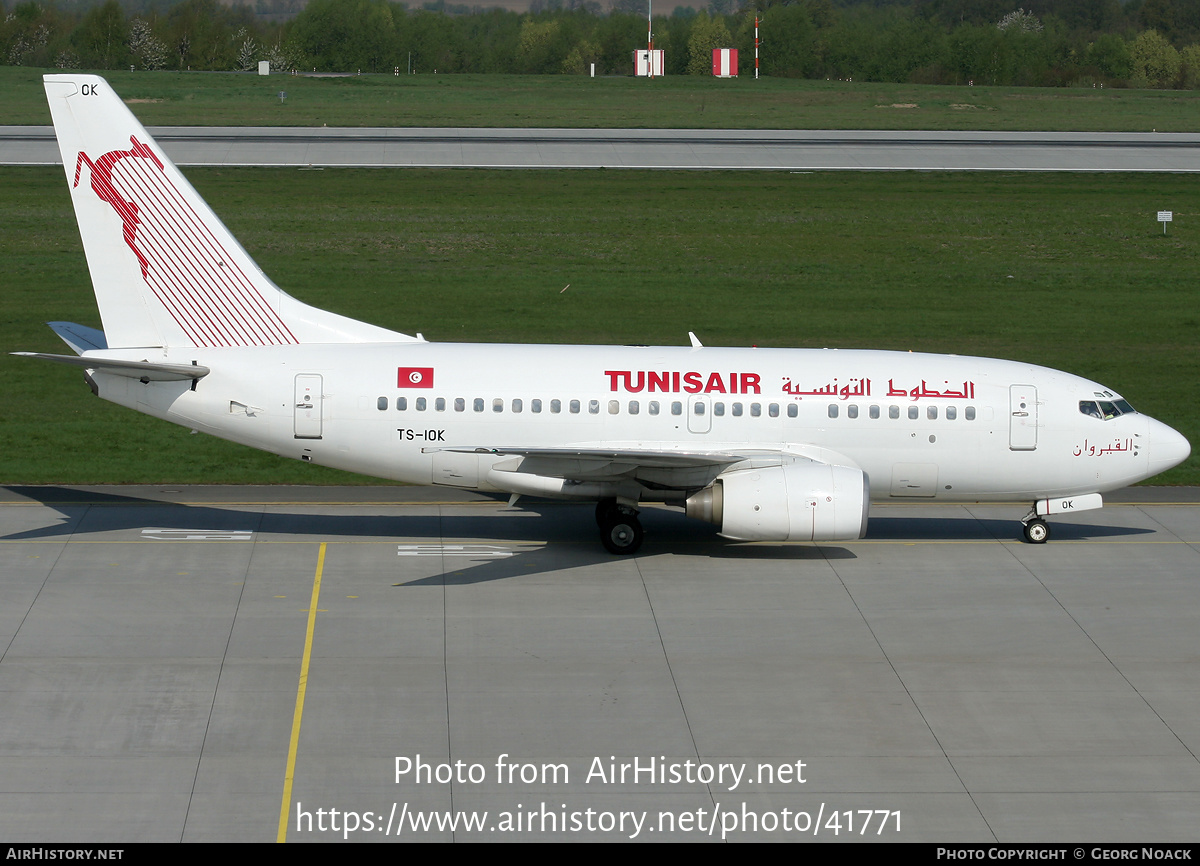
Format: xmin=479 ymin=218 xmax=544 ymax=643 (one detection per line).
xmin=7 ymin=126 xmax=1200 ymax=172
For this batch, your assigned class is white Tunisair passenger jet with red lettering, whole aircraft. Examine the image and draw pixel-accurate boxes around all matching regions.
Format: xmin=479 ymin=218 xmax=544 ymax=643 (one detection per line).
xmin=17 ymin=73 xmax=1190 ymax=554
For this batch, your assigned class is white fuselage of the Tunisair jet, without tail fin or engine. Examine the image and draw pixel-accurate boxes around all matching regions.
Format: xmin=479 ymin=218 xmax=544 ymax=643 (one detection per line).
xmin=94 ymin=343 xmax=1186 ymax=500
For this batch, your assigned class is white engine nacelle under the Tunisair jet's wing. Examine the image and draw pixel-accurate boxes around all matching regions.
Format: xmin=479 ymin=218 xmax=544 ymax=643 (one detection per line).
xmin=688 ymin=459 xmax=871 ymax=541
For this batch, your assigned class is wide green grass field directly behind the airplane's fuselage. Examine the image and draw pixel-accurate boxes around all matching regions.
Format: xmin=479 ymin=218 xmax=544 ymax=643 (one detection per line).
xmin=0 ymin=168 xmax=1200 ymax=483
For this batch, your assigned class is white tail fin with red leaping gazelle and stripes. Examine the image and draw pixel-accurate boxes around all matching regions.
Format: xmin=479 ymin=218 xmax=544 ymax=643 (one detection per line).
xmin=43 ymin=74 xmax=414 ymax=348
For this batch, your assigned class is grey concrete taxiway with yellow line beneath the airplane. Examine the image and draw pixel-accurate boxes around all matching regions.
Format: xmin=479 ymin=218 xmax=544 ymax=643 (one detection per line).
xmin=0 ymin=486 xmax=1200 ymax=843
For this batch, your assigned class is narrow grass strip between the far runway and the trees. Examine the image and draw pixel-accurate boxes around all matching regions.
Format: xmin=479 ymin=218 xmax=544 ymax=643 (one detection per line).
xmin=0 ymin=67 xmax=1200 ymax=132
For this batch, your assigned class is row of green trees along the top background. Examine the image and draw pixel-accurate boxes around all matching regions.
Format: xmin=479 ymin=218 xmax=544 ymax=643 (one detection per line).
xmin=7 ymin=0 xmax=1200 ymax=89
